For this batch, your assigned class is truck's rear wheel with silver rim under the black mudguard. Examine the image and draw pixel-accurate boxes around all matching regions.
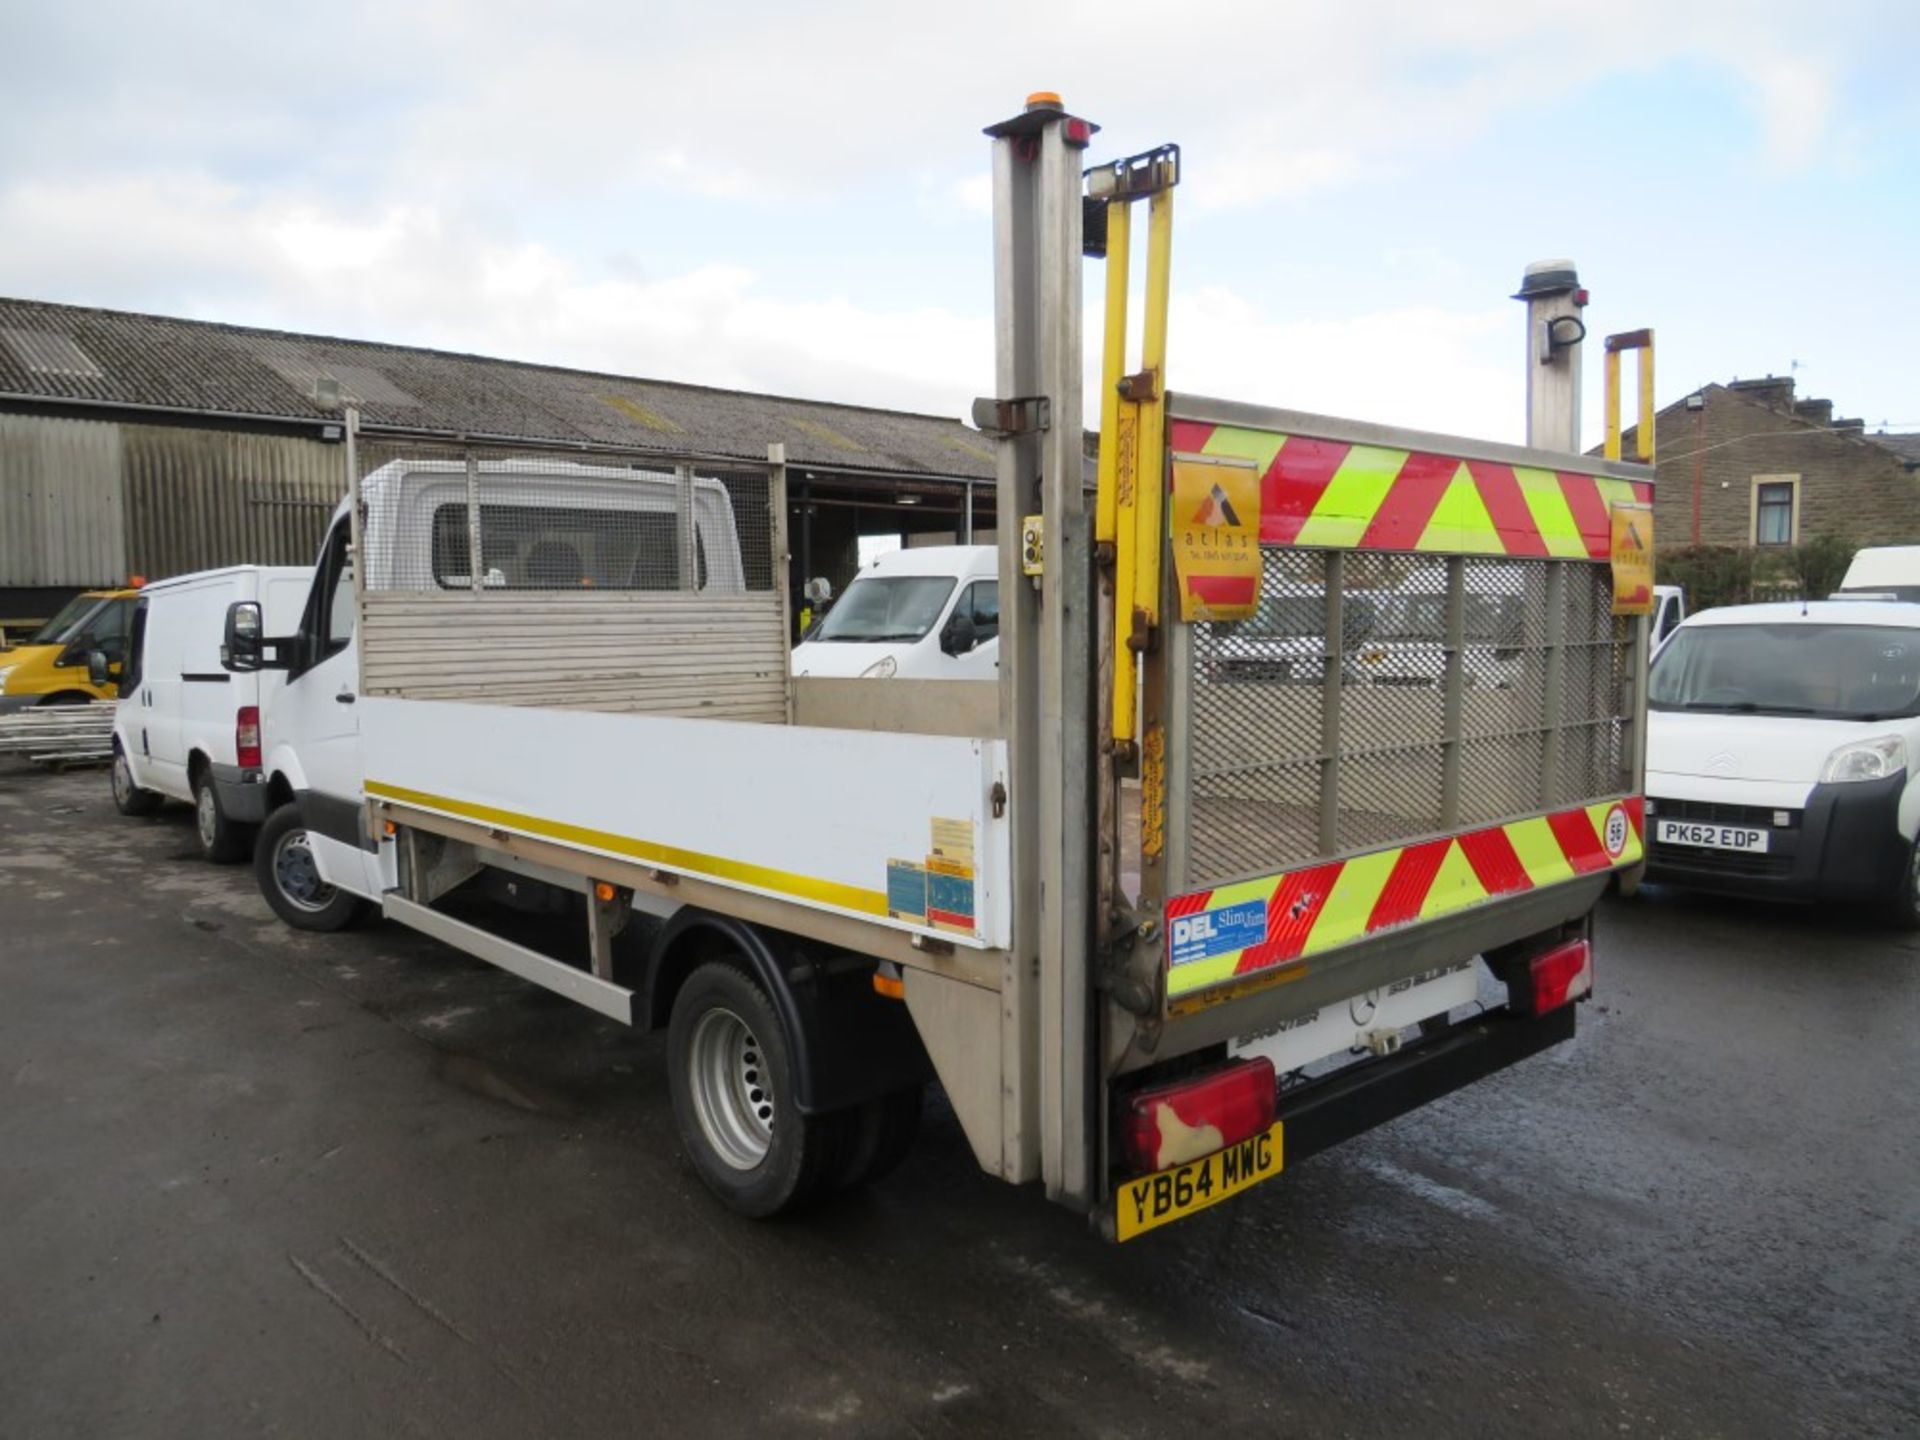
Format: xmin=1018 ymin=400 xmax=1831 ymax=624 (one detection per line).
xmin=666 ymin=960 xmax=845 ymax=1219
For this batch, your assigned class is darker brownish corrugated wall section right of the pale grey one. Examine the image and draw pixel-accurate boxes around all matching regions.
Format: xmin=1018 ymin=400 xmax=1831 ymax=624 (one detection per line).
xmin=121 ymin=424 xmax=348 ymax=580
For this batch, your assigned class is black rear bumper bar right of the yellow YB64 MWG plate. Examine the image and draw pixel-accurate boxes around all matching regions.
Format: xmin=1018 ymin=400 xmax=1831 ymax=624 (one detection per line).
xmin=1279 ymin=1004 xmax=1576 ymax=1165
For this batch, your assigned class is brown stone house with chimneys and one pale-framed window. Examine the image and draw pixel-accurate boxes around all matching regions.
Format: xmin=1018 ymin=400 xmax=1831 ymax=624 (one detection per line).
xmin=1624 ymin=376 xmax=1920 ymax=547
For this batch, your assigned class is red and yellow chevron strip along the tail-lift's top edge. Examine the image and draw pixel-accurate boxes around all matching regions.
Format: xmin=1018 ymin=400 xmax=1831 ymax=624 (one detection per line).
xmin=1167 ymin=420 xmax=1653 ymax=561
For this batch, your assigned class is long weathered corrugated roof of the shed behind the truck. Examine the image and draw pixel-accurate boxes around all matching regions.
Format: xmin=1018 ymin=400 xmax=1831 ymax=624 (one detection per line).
xmin=0 ymin=298 xmax=995 ymax=478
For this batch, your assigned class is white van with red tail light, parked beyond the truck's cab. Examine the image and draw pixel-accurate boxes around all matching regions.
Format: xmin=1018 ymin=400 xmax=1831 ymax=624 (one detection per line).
xmin=113 ymin=564 xmax=313 ymax=860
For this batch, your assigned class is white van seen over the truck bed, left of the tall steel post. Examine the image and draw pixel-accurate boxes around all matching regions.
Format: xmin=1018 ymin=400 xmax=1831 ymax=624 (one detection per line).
xmin=793 ymin=545 xmax=1000 ymax=680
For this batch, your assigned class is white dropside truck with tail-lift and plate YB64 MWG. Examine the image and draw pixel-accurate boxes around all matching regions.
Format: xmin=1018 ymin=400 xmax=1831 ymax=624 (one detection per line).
xmin=217 ymin=98 xmax=1651 ymax=1240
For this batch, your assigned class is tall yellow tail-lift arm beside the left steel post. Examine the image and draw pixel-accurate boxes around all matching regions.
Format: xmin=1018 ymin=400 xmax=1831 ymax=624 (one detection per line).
xmin=1087 ymin=146 xmax=1181 ymax=747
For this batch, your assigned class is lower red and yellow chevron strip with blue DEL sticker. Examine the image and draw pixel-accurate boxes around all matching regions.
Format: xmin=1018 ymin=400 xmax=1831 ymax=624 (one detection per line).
xmin=1167 ymin=795 xmax=1644 ymax=1000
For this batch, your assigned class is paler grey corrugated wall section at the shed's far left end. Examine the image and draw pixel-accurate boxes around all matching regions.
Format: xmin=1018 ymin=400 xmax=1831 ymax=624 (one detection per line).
xmin=0 ymin=415 xmax=127 ymax=588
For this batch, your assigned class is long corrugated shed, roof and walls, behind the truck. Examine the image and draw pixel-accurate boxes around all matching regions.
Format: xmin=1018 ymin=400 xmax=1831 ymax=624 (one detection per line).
xmin=0 ymin=300 xmax=993 ymax=622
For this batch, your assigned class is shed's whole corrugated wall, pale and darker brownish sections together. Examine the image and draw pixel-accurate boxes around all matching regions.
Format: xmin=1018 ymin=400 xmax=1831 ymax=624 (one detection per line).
xmin=0 ymin=415 xmax=346 ymax=589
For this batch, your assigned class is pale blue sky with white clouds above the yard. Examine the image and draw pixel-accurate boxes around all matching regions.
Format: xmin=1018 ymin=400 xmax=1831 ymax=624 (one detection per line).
xmin=0 ymin=0 xmax=1920 ymax=449
